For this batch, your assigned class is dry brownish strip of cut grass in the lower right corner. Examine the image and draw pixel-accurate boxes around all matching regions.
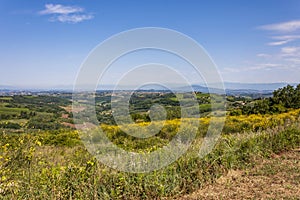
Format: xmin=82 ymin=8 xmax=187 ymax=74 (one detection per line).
xmin=179 ymin=149 xmax=300 ymax=199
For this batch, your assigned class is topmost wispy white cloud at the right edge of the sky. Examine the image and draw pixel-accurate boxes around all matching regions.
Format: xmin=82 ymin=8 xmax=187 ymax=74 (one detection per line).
xmin=258 ymin=20 xmax=300 ymax=32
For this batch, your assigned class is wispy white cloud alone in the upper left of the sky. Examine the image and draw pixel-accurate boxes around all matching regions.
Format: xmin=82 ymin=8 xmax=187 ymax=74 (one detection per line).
xmin=38 ymin=4 xmax=94 ymax=24
